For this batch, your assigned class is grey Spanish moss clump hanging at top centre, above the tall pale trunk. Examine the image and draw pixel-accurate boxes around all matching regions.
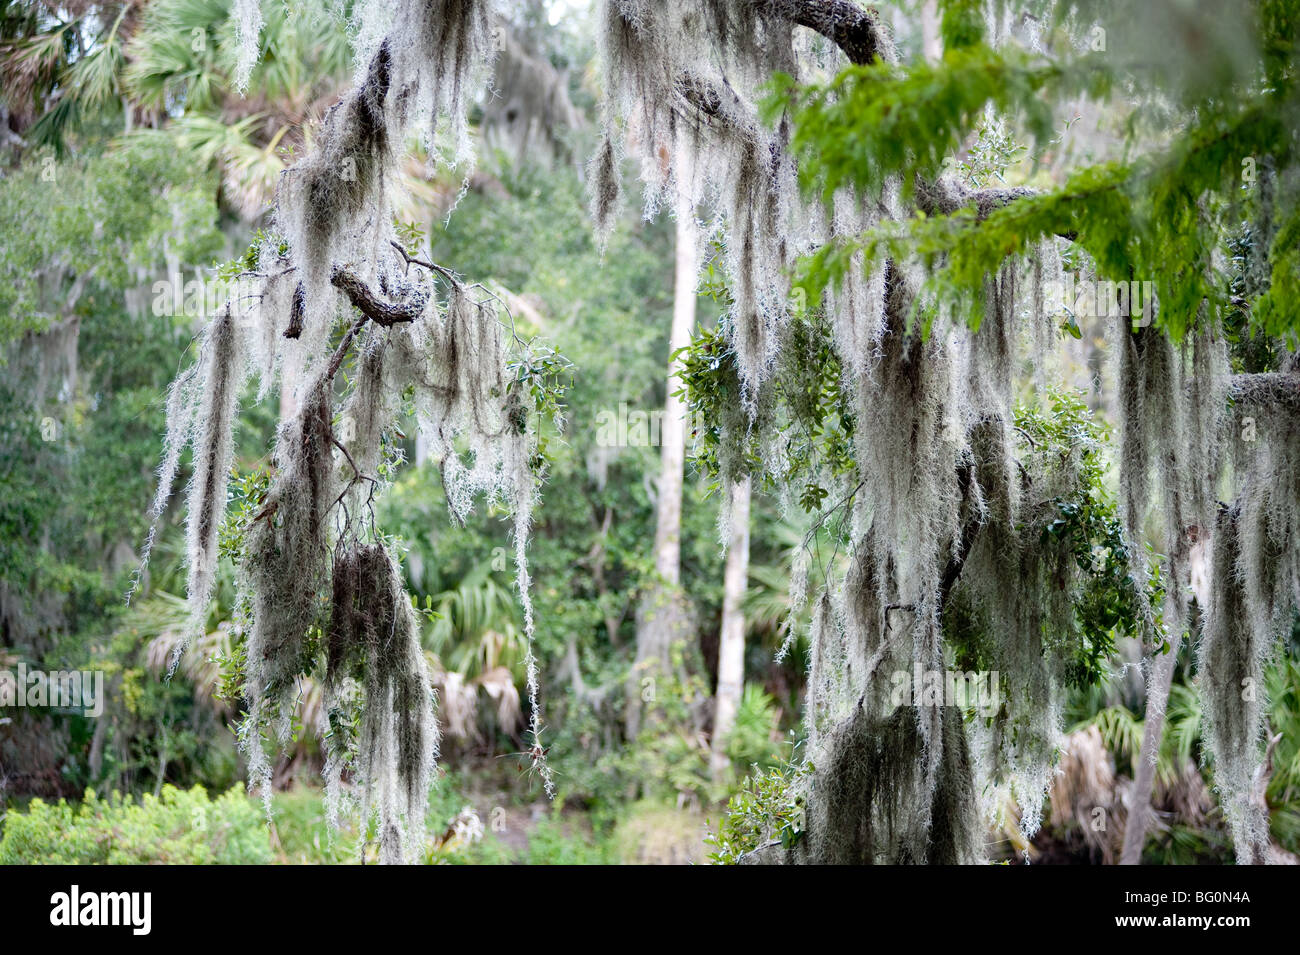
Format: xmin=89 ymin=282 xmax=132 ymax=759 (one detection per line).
xmin=592 ymin=0 xmax=809 ymax=402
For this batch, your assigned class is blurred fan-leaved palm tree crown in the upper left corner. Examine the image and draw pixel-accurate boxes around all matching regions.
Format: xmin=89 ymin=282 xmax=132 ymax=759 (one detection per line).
xmin=0 ymin=0 xmax=352 ymax=221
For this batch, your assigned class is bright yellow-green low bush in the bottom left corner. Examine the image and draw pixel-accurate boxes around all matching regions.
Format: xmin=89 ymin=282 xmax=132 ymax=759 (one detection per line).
xmin=0 ymin=785 xmax=270 ymax=865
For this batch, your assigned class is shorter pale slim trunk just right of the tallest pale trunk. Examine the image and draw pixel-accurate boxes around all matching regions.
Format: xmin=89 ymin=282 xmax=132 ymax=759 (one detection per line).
xmin=709 ymin=477 xmax=750 ymax=781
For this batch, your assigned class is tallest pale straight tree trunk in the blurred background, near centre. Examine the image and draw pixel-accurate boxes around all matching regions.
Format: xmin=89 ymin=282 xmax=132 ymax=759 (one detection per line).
xmin=627 ymin=158 xmax=698 ymax=739
